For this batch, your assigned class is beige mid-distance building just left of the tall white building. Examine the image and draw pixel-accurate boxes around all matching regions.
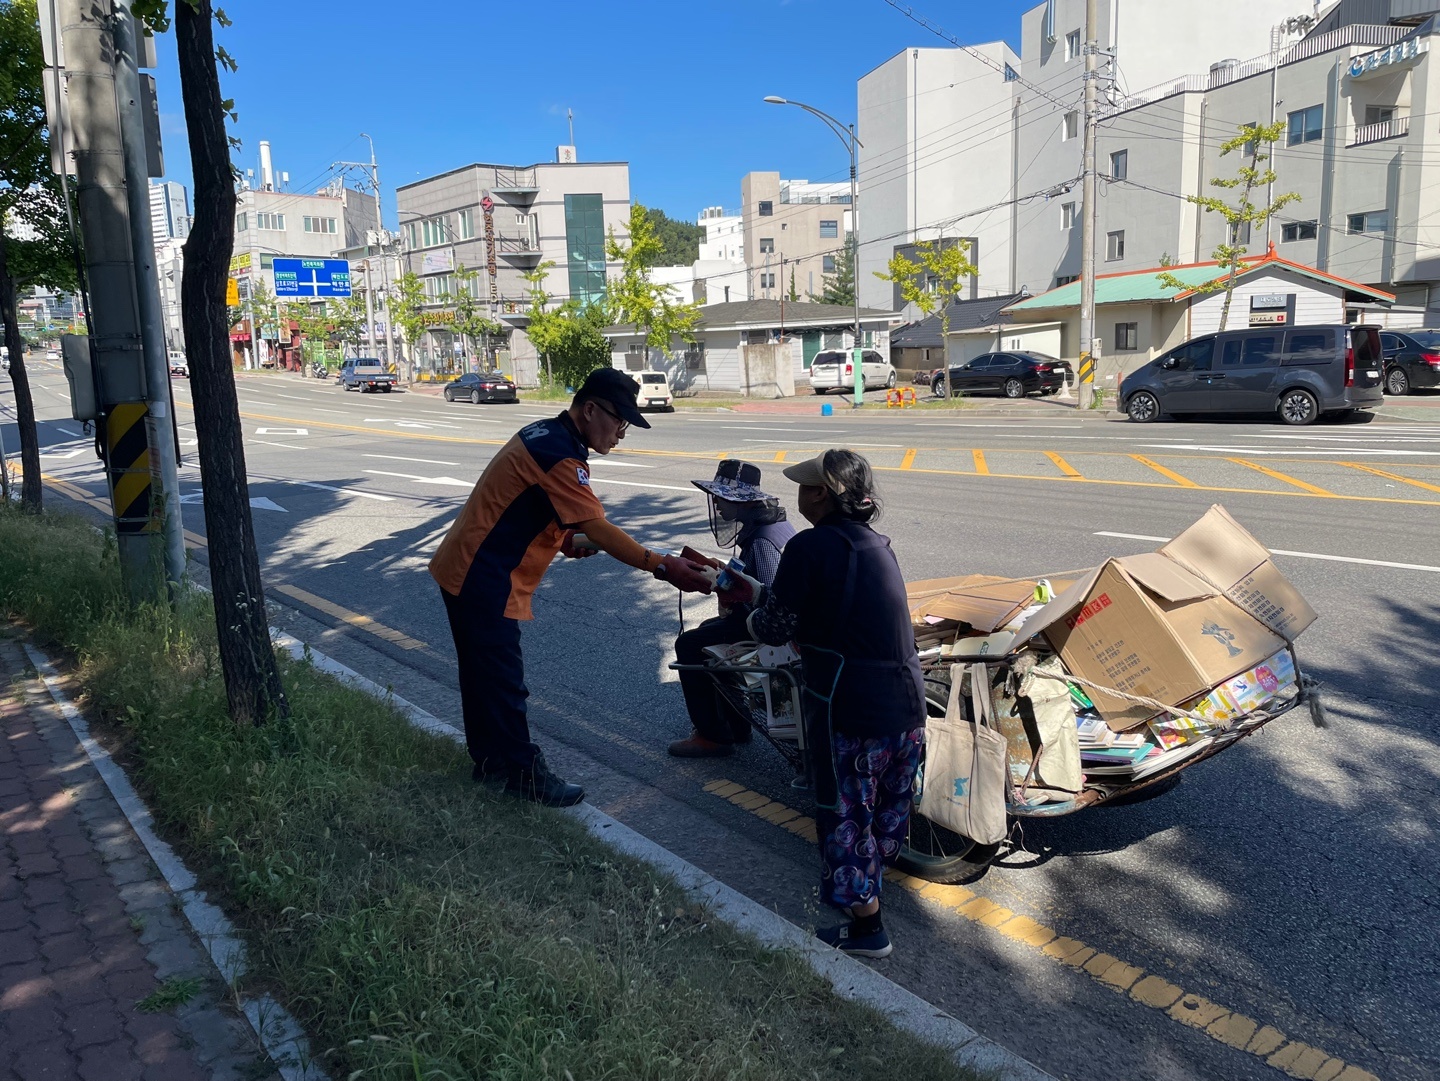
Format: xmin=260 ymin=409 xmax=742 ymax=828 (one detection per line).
xmin=740 ymin=173 xmax=852 ymax=302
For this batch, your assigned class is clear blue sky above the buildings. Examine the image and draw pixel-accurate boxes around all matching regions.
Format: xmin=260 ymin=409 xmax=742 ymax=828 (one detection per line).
xmin=156 ymin=0 xmax=1038 ymax=229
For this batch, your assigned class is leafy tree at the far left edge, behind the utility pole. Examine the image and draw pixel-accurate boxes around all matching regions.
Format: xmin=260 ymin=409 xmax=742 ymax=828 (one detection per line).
xmin=0 ymin=0 xmax=76 ymax=514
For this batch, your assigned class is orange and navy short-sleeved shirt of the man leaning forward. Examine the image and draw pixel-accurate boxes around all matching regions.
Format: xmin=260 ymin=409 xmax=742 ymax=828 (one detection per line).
xmin=431 ymin=413 xmax=605 ymax=619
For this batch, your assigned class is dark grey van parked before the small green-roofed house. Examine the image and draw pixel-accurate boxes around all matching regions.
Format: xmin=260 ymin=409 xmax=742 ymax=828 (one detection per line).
xmin=1120 ymin=324 xmax=1385 ymax=425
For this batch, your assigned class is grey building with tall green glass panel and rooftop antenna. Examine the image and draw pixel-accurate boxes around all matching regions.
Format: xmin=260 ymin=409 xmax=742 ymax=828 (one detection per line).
xmin=396 ymin=147 xmax=629 ymax=386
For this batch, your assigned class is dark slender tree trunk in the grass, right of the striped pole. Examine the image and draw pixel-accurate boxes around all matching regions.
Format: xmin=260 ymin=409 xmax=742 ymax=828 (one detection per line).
xmin=174 ymin=0 xmax=289 ymax=724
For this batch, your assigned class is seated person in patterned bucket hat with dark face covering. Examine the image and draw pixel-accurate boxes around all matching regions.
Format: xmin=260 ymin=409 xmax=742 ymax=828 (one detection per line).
xmin=670 ymin=458 xmax=795 ymax=759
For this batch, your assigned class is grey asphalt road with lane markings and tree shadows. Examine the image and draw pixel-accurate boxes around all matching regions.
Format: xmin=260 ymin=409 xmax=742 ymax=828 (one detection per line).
xmin=14 ymin=361 xmax=1440 ymax=1081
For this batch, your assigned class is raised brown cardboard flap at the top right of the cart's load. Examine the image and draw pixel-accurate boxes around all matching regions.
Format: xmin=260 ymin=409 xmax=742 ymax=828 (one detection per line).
xmin=1159 ymin=504 xmax=1316 ymax=641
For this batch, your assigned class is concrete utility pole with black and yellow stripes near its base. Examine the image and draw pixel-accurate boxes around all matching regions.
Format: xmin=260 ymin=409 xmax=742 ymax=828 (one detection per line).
xmin=55 ymin=0 xmax=184 ymax=600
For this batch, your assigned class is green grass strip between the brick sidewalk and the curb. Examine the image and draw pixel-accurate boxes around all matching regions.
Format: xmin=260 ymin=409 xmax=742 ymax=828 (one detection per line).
xmin=0 ymin=508 xmax=972 ymax=1081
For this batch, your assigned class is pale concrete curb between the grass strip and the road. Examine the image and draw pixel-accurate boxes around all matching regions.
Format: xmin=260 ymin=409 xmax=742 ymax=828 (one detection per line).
xmin=271 ymin=628 xmax=1056 ymax=1081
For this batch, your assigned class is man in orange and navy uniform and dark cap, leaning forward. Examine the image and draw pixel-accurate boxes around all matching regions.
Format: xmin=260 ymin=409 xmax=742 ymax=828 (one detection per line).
xmin=429 ymin=368 xmax=710 ymax=806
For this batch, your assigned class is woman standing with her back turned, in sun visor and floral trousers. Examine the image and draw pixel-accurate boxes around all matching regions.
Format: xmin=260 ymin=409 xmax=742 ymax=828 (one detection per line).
xmin=720 ymin=451 xmax=924 ymax=957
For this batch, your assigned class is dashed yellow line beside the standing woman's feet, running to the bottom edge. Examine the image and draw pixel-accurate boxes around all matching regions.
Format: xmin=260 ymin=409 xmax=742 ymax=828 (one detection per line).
xmin=704 ymin=777 xmax=1380 ymax=1081
